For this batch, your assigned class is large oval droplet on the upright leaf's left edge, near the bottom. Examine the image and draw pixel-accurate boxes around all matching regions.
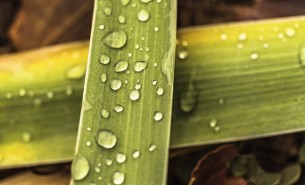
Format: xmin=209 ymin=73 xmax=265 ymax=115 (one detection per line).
xmin=72 ymin=153 xmax=90 ymax=181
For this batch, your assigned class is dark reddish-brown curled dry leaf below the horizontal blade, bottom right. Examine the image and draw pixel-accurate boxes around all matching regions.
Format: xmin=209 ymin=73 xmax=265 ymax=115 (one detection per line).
xmin=189 ymin=144 xmax=248 ymax=185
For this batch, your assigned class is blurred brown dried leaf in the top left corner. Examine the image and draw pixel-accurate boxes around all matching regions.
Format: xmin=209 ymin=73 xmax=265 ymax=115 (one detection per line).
xmin=9 ymin=0 xmax=93 ymax=50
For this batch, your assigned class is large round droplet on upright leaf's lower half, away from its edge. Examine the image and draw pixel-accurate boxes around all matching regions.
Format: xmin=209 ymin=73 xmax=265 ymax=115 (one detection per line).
xmin=95 ymin=129 xmax=117 ymax=149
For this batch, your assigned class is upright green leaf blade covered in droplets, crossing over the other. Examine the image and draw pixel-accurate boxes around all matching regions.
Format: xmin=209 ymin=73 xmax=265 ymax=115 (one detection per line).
xmin=72 ymin=0 xmax=176 ymax=185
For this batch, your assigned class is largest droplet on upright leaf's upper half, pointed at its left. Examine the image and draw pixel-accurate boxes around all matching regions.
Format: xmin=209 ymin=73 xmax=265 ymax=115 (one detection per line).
xmin=102 ymin=29 xmax=127 ymax=49
